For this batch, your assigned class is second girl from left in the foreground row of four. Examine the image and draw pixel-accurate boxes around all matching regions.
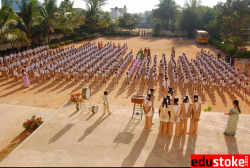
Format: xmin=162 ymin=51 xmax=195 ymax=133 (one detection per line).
xmin=168 ymin=98 xmax=181 ymax=136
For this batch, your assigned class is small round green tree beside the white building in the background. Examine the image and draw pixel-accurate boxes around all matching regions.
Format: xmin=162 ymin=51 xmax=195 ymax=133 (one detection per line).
xmin=116 ymin=13 xmax=141 ymax=31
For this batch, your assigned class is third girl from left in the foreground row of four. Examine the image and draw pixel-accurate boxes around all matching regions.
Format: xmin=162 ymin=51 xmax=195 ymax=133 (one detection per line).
xmin=180 ymin=96 xmax=192 ymax=134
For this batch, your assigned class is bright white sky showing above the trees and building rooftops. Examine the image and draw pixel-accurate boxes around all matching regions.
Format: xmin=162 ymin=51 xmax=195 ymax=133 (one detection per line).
xmin=57 ymin=0 xmax=226 ymax=13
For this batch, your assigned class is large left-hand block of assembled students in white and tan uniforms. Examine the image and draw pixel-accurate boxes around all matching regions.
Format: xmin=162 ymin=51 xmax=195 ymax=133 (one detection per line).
xmin=0 ymin=42 xmax=129 ymax=87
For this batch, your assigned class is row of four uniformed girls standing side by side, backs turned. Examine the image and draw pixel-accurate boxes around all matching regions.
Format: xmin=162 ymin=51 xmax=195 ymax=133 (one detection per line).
xmin=159 ymin=95 xmax=201 ymax=136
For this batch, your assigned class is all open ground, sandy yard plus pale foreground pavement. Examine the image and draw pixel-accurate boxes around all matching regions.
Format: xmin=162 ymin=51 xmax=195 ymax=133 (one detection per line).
xmin=0 ymin=35 xmax=250 ymax=166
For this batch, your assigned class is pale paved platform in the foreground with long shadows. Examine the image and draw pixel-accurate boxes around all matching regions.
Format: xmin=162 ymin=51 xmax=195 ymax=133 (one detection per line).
xmin=0 ymin=104 xmax=250 ymax=167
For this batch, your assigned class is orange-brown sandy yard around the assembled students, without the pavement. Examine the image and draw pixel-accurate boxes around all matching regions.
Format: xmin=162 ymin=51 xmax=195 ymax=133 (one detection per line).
xmin=0 ymin=35 xmax=250 ymax=114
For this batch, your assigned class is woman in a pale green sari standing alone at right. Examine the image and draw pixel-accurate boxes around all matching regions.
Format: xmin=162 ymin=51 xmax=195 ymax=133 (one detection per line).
xmin=223 ymin=100 xmax=241 ymax=136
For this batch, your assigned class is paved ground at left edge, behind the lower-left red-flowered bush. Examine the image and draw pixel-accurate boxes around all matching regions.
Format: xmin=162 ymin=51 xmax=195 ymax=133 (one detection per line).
xmin=0 ymin=104 xmax=55 ymax=151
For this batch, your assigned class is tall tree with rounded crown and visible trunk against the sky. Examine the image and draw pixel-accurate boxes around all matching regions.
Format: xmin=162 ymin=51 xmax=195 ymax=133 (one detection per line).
xmin=153 ymin=0 xmax=180 ymax=29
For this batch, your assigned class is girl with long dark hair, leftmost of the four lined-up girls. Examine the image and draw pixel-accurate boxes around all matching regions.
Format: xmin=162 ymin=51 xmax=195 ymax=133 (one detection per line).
xmin=159 ymin=98 xmax=170 ymax=135
